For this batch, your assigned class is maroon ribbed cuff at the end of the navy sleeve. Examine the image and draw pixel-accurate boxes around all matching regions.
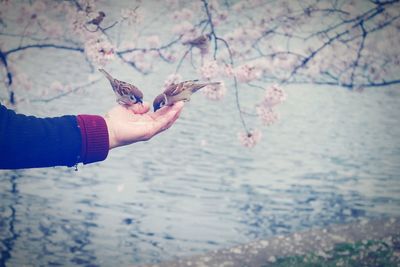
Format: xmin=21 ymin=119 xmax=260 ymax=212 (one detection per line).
xmin=77 ymin=115 xmax=109 ymax=164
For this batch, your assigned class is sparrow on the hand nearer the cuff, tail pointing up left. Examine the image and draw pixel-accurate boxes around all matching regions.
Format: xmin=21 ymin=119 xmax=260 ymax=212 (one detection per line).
xmin=99 ymin=69 xmax=143 ymax=106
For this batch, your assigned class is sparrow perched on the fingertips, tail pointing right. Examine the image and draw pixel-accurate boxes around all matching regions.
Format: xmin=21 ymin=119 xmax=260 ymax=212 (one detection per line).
xmin=153 ymin=80 xmax=220 ymax=111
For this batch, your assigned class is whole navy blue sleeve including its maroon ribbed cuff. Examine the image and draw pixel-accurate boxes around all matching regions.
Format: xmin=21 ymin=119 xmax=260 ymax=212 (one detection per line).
xmin=0 ymin=105 xmax=108 ymax=169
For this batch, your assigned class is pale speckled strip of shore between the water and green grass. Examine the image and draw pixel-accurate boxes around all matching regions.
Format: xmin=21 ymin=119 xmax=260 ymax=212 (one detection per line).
xmin=140 ymin=218 xmax=400 ymax=267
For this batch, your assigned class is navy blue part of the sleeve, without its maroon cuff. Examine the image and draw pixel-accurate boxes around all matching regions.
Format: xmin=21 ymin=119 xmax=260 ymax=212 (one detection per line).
xmin=0 ymin=104 xmax=82 ymax=169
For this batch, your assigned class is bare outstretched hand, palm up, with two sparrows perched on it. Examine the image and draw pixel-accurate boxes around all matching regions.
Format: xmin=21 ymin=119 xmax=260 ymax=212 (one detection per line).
xmin=104 ymin=101 xmax=184 ymax=149
